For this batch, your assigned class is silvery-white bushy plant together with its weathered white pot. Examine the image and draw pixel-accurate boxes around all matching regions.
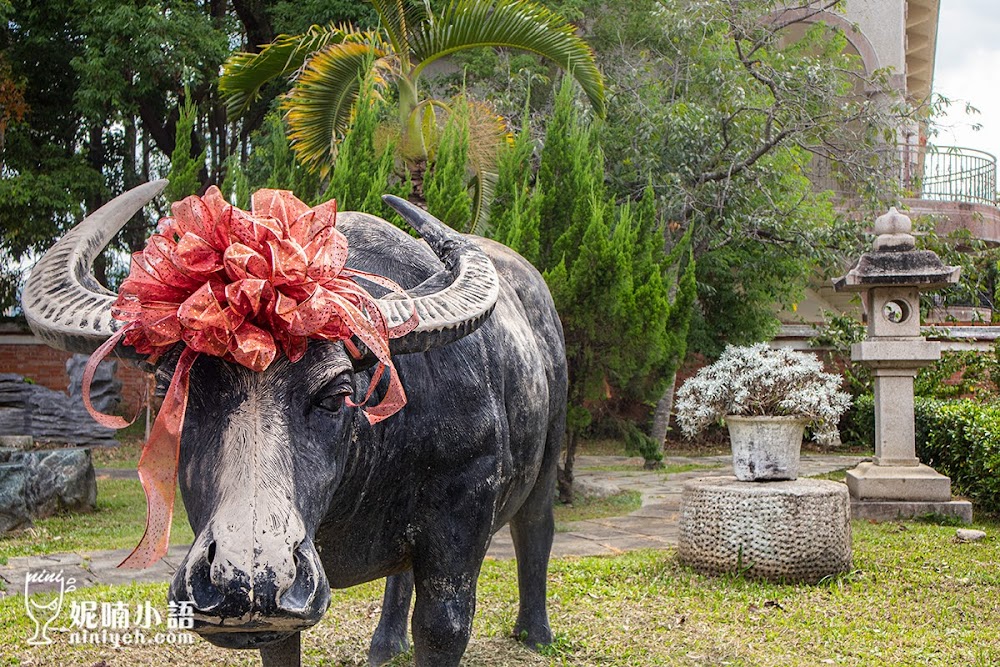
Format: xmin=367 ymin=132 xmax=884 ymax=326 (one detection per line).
xmin=677 ymin=343 xmax=851 ymax=481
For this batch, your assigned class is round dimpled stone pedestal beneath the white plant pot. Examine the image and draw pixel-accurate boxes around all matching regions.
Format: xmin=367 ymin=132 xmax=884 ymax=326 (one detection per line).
xmin=677 ymin=477 xmax=851 ymax=583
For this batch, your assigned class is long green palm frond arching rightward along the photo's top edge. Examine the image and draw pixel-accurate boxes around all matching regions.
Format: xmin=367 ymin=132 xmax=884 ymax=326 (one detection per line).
xmin=409 ymin=0 xmax=604 ymax=116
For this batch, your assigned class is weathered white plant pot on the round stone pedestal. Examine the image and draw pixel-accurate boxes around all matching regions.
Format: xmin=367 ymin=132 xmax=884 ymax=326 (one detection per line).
xmin=726 ymin=415 xmax=806 ymax=482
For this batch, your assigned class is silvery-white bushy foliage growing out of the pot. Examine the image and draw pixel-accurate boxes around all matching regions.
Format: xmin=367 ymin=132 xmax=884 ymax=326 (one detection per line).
xmin=676 ymin=343 xmax=851 ymax=442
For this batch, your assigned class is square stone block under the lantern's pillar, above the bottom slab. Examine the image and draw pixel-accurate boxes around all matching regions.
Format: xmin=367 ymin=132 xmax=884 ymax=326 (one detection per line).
xmin=847 ymin=462 xmax=951 ymax=503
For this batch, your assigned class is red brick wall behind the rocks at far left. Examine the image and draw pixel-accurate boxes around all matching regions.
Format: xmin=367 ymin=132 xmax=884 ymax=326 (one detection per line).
xmin=0 ymin=336 xmax=147 ymax=417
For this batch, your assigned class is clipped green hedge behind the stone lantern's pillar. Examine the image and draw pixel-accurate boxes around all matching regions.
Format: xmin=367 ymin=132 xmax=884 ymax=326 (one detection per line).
xmin=841 ymin=395 xmax=1000 ymax=514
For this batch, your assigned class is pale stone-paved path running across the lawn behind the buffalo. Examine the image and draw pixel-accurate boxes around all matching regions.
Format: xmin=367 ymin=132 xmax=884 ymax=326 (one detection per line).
xmin=0 ymin=455 xmax=861 ymax=597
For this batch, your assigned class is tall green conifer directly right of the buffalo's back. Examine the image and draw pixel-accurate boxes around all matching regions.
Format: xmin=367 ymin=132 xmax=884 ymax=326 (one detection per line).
xmin=532 ymin=84 xmax=695 ymax=490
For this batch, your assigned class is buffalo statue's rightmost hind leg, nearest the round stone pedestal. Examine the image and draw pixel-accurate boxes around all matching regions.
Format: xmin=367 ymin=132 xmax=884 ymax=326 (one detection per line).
xmin=510 ymin=466 xmax=556 ymax=648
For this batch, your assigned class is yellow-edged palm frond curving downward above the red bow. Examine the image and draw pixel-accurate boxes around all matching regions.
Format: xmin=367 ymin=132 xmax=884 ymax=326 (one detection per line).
xmin=282 ymin=43 xmax=386 ymax=174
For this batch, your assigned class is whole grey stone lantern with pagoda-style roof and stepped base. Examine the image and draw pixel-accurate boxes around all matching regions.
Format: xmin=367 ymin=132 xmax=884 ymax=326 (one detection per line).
xmin=834 ymin=208 xmax=972 ymax=521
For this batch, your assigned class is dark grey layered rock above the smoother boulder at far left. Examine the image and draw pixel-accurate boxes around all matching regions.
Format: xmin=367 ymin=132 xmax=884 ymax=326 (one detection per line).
xmin=0 ymin=373 xmax=118 ymax=447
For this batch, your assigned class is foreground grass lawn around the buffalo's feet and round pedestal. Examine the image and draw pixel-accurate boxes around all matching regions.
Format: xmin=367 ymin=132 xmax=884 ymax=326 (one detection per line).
xmin=0 ymin=522 xmax=1000 ymax=667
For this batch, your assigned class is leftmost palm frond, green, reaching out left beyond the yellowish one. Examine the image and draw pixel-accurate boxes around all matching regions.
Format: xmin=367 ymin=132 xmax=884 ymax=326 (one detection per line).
xmin=219 ymin=24 xmax=369 ymax=118
